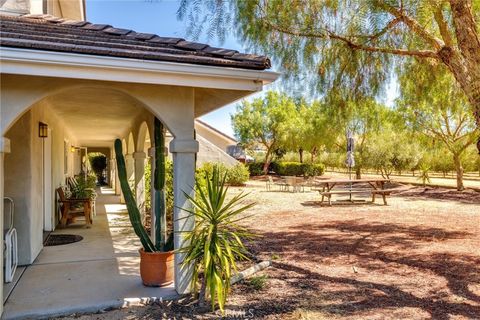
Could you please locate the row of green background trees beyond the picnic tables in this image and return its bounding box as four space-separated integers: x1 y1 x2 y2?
232 79 480 190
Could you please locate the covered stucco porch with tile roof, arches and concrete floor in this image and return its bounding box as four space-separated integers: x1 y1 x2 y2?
0 12 278 317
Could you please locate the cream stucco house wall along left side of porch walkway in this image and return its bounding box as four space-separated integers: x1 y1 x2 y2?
4 103 75 265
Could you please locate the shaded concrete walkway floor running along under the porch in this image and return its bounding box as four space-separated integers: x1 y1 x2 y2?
3 188 176 319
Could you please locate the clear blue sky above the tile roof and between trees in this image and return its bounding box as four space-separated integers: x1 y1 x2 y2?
86 0 397 136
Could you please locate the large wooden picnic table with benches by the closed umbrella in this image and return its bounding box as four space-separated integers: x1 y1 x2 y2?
314 178 392 205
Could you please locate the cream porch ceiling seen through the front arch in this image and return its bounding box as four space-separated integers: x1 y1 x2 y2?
47 88 144 146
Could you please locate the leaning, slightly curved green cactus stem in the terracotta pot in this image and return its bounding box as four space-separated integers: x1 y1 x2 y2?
115 139 158 252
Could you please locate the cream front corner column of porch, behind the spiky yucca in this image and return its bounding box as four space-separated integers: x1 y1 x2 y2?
170 139 198 294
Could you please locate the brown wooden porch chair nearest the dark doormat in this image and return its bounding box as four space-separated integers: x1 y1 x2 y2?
55 187 92 227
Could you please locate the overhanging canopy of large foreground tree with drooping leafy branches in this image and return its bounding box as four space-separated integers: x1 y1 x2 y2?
178 0 480 148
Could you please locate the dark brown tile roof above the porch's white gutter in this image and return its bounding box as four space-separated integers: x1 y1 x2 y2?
0 15 271 70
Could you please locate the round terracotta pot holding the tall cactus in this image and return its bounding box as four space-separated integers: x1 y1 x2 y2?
138 248 174 287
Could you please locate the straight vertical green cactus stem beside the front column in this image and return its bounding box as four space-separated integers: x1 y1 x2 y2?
153 118 170 251
